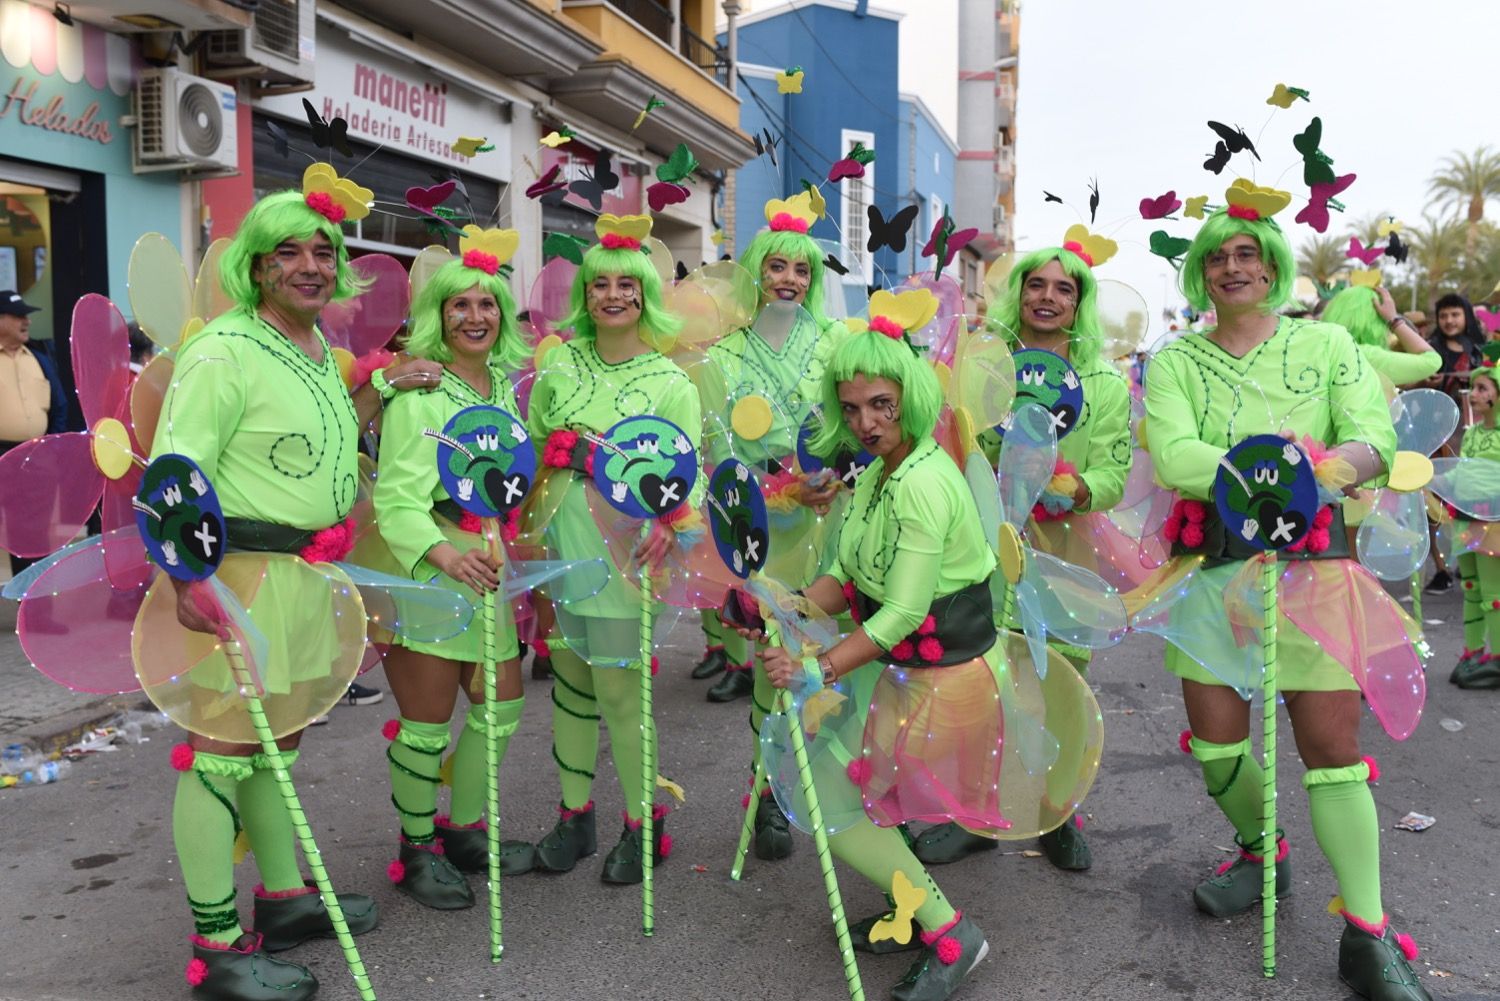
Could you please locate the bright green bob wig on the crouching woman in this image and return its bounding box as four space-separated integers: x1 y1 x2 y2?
810 330 942 458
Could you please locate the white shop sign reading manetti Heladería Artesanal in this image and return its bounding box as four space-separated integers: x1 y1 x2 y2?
254 23 510 180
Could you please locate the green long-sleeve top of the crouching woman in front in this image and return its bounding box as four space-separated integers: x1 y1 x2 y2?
830 438 995 650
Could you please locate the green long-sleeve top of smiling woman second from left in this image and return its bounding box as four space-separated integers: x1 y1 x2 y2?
375 365 521 581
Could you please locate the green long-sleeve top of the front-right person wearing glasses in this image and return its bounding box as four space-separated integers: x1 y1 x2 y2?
1146 318 1397 500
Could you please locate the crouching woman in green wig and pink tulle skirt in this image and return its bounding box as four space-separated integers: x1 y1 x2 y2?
761 317 1008 1001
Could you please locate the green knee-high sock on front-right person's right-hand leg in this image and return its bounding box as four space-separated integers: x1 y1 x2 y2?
1302 761 1385 924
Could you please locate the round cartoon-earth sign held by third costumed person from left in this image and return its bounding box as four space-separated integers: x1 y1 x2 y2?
594 417 698 518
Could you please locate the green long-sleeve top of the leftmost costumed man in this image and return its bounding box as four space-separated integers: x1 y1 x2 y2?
152 309 359 530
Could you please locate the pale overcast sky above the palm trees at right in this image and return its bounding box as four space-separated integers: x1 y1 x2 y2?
1014 0 1500 333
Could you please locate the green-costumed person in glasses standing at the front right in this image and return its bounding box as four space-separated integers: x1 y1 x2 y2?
1145 199 1428 1001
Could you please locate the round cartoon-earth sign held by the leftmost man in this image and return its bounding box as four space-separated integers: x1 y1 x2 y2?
131 453 227 581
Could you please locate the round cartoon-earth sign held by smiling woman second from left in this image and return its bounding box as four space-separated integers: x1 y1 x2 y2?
423 407 537 518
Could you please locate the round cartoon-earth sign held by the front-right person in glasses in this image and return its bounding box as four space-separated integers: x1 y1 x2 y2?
1214 434 1319 549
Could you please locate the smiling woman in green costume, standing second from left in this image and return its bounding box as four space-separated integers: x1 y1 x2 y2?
375 238 533 909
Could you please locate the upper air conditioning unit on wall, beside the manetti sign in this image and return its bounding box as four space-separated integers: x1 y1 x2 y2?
203 0 318 93
